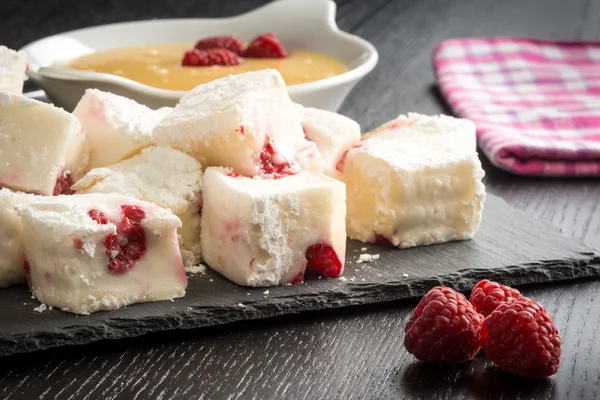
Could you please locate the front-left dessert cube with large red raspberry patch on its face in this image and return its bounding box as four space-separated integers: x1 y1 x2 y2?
17 194 187 314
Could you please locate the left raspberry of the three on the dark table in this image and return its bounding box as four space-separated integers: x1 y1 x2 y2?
404 286 483 364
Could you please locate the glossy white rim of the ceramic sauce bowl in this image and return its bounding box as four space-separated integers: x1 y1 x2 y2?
19 0 379 98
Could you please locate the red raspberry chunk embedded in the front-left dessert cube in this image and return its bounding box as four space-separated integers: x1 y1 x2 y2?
104 205 146 273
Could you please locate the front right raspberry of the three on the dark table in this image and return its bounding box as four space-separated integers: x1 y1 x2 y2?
481 297 561 379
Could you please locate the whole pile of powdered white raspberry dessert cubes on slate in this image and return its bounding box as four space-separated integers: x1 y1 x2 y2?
0 49 485 314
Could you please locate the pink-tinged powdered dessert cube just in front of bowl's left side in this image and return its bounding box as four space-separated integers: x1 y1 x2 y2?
73 89 164 170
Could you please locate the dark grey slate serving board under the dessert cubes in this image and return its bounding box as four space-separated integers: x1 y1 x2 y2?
0 196 600 356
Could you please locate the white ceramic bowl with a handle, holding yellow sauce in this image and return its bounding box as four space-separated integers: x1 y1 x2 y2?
22 0 378 111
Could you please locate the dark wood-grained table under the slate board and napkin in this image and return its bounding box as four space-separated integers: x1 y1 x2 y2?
0 0 600 400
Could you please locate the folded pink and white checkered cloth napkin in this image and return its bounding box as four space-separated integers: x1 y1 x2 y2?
433 38 600 176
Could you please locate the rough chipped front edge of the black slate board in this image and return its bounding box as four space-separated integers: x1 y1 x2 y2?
0 252 600 356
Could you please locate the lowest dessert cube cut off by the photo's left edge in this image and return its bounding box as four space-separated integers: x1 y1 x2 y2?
0 189 36 287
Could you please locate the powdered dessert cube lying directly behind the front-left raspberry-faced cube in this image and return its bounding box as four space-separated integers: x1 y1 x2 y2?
73 146 202 269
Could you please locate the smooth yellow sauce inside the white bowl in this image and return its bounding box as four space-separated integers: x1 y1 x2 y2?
61 43 348 90
